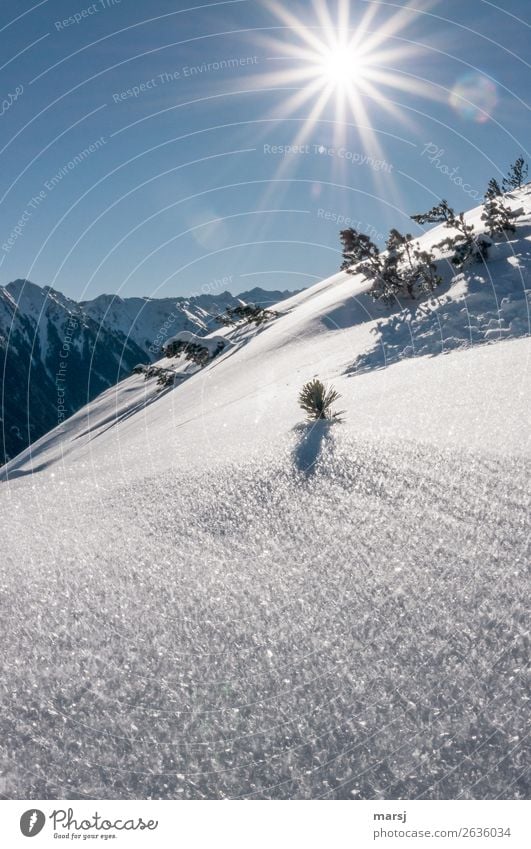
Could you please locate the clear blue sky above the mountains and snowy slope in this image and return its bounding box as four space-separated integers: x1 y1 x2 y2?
0 0 531 298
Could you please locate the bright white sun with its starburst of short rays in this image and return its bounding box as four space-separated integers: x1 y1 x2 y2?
255 0 432 152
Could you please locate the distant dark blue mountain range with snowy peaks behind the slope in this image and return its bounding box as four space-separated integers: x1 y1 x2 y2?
0 280 293 464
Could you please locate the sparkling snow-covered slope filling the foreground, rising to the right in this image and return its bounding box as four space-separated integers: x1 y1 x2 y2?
0 191 531 798
